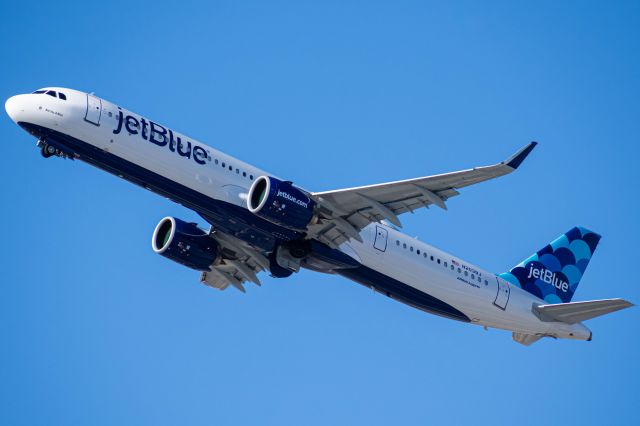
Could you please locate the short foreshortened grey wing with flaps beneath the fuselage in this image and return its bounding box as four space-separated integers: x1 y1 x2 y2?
200 231 269 293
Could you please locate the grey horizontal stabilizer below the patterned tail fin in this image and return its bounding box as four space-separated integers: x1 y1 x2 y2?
533 299 633 324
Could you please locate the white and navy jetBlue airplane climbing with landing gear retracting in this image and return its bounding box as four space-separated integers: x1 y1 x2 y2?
5 87 633 346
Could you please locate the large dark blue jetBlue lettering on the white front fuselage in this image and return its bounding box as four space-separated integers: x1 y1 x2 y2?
113 109 207 164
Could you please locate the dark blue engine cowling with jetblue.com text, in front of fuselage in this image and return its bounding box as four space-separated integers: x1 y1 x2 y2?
247 176 315 232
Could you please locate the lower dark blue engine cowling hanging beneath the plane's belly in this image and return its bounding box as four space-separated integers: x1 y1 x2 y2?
151 217 220 271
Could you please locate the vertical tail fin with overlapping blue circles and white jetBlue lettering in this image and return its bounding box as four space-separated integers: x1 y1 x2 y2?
500 226 600 303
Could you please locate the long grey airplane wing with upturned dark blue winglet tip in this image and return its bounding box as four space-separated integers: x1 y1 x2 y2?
309 142 537 247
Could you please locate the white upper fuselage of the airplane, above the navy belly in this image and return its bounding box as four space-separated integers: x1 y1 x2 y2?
6 88 591 340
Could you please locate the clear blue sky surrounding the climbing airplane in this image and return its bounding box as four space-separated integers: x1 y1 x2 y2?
0 1 640 425
